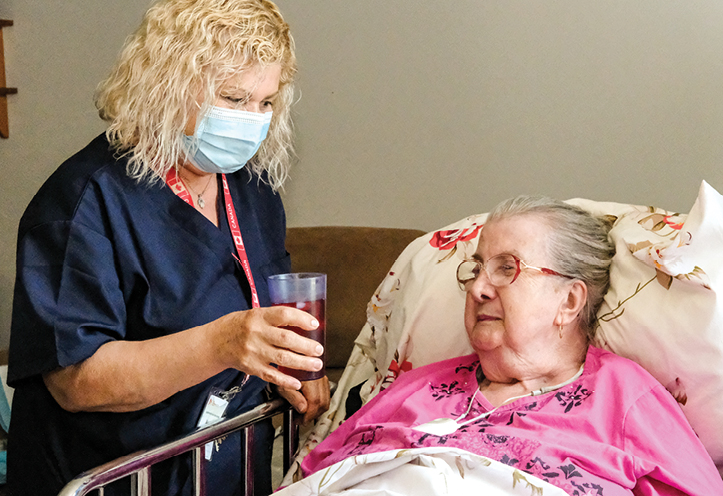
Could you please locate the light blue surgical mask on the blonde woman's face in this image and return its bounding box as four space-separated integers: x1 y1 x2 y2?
185 107 273 174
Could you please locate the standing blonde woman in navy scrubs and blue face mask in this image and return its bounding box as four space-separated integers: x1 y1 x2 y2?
8 0 329 496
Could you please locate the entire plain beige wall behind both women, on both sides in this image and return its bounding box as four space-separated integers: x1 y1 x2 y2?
0 0 723 346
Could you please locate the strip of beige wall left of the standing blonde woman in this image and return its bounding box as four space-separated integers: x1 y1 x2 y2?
0 0 150 348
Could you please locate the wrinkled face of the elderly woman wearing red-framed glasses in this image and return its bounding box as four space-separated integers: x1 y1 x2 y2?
465 215 568 378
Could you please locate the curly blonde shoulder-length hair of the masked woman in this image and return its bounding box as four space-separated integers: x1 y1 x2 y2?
95 0 296 190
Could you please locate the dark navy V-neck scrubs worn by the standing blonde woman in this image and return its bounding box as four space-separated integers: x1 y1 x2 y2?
8 136 290 496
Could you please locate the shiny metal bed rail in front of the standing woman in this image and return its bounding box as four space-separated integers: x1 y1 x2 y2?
58 398 299 496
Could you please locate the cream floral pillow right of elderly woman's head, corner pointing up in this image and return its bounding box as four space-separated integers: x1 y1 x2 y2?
588 182 723 468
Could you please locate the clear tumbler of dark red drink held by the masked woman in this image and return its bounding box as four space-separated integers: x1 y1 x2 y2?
269 272 326 381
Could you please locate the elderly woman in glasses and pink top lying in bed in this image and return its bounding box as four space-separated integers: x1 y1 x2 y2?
296 197 723 496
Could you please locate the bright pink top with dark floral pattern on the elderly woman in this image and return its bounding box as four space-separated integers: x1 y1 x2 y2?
302 347 723 496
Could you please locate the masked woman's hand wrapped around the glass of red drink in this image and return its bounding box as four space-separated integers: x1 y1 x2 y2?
208 306 328 392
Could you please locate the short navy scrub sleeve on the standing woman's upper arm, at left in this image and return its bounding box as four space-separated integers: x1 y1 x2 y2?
8 221 126 383
